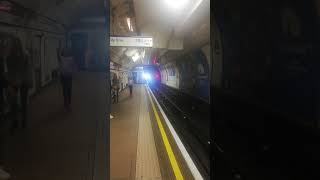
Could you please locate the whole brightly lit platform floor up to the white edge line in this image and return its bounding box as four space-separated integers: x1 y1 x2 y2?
110 84 198 180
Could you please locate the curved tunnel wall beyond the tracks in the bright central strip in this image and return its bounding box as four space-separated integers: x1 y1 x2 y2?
160 45 211 102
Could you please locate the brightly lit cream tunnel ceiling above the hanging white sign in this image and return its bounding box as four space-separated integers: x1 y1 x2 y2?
110 0 210 68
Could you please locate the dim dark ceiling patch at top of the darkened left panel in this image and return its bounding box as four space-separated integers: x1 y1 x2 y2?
10 0 104 29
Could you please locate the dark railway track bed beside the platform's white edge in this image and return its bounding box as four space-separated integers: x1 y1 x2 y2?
150 85 210 179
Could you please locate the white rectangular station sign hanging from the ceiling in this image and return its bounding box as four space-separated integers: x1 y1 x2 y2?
110 36 153 47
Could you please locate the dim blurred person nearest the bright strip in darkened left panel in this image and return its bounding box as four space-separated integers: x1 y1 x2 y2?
58 48 76 111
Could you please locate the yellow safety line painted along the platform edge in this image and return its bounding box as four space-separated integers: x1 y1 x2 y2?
147 86 183 180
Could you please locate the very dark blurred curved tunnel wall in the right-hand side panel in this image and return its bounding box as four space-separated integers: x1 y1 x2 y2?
214 0 319 127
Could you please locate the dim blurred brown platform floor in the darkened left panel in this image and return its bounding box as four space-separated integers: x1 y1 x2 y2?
1 72 107 180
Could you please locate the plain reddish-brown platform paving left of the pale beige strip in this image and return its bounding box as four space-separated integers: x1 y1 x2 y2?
110 86 141 180
